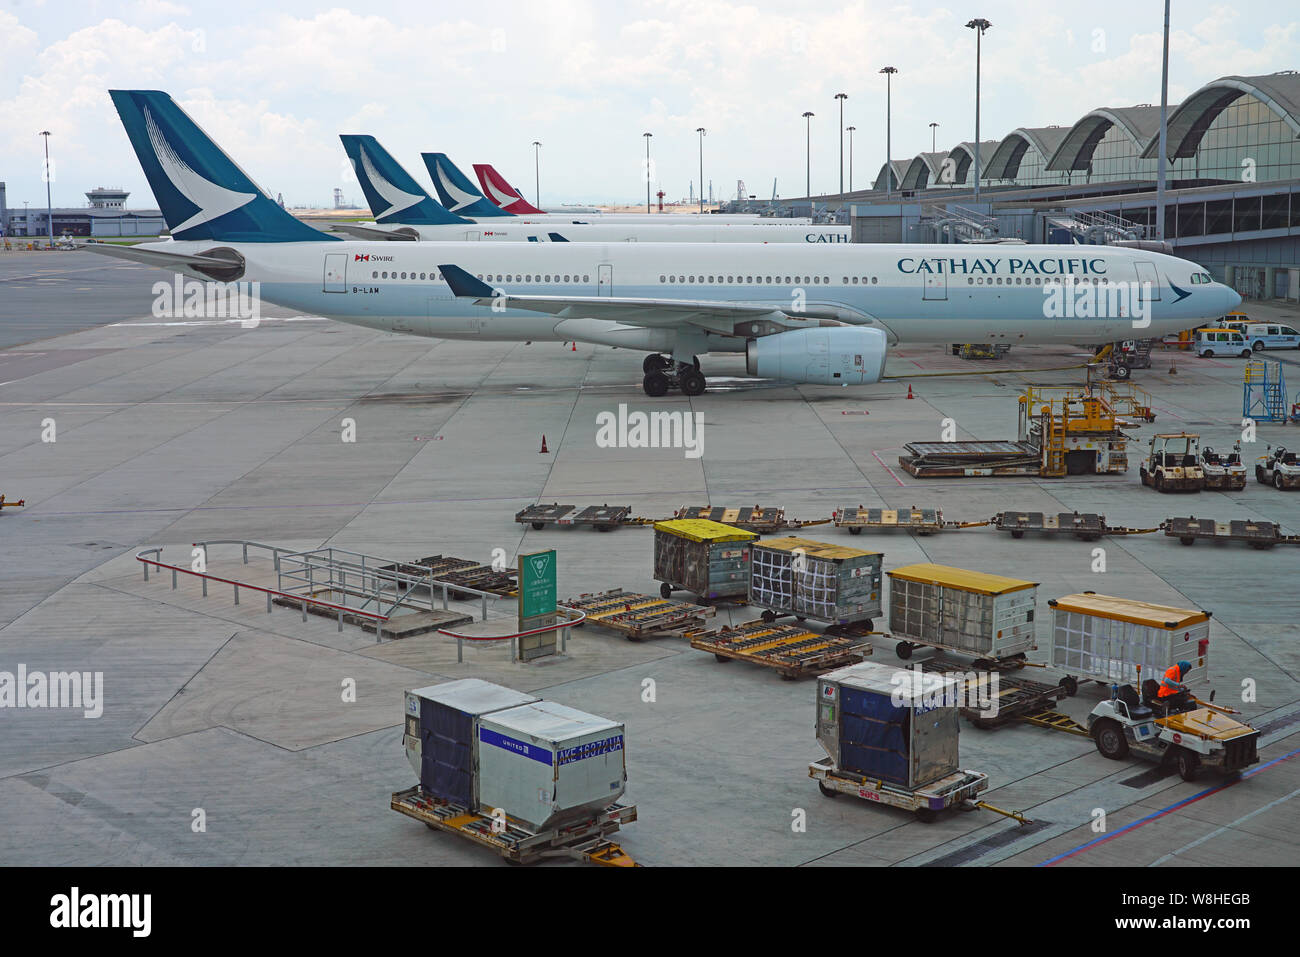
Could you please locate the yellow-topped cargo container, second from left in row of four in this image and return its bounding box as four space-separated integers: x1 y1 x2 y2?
749 536 884 631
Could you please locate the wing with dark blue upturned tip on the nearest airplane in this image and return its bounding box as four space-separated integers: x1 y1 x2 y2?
438 264 800 335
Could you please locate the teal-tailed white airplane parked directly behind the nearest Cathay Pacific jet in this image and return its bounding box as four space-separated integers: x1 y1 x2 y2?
334 133 853 243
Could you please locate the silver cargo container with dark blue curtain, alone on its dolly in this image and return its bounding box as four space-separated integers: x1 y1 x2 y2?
816 662 959 791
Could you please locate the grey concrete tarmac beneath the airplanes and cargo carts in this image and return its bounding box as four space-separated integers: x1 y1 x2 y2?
0 252 1300 866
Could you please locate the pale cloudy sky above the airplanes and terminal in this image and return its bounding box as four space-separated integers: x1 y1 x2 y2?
0 0 1300 208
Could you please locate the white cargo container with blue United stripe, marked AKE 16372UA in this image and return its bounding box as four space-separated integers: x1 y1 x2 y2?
477 701 628 830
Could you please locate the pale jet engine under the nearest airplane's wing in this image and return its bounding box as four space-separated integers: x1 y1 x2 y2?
745 326 888 385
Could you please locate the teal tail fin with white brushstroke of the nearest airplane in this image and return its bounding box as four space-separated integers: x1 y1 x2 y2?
108 90 337 243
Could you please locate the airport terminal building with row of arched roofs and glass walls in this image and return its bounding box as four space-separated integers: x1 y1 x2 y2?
732 70 1300 300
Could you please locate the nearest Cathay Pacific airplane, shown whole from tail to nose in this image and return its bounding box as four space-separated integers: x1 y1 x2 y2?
81 90 1242 397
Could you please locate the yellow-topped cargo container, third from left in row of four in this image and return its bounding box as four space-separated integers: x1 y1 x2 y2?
888 564 1039 661
